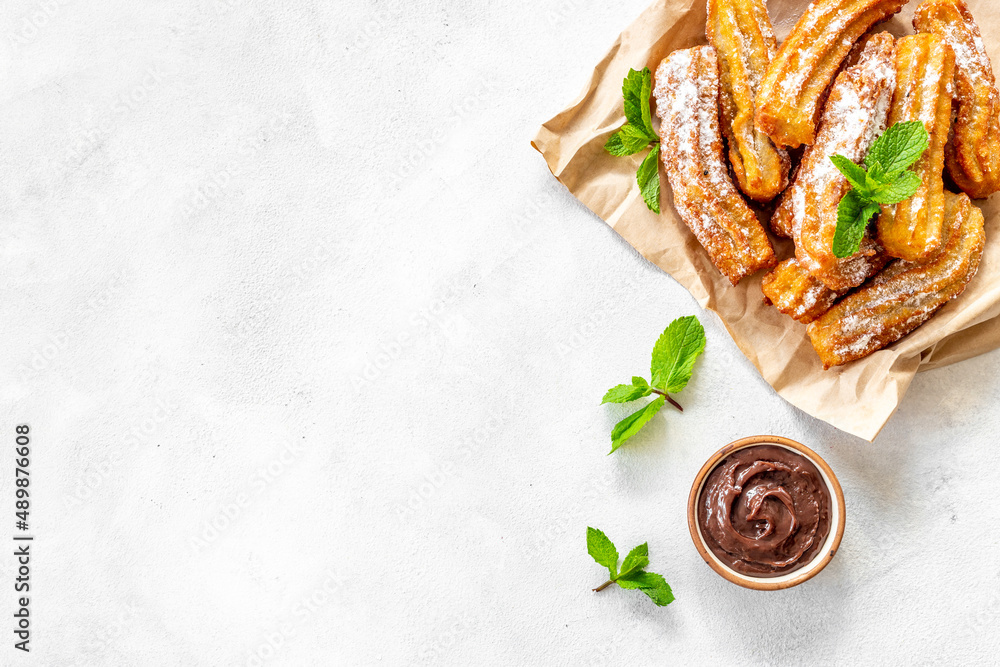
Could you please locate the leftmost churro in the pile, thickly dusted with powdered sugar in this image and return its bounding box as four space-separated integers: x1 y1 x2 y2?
653 46 776 285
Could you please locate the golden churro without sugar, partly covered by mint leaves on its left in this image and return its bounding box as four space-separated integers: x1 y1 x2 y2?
878 34 955 262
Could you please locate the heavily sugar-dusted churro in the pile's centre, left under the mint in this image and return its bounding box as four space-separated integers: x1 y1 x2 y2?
771 33 896 291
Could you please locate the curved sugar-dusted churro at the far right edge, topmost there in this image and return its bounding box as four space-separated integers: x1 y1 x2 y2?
913 0 1000 199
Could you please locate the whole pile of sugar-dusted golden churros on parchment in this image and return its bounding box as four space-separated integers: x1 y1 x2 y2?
652 0 1000 368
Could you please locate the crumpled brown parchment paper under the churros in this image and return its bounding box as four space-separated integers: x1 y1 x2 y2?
532 0 1000 440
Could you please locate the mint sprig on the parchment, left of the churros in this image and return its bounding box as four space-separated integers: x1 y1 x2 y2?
604 67 660 213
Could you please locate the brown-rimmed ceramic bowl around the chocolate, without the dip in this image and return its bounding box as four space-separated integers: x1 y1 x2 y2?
688 435 846 591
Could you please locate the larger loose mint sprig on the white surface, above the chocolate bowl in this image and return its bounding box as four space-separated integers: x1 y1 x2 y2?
601 315 705 454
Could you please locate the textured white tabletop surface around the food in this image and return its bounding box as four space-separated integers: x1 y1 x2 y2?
0 0 1000 666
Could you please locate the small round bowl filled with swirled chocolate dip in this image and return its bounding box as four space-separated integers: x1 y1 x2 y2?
688 435 845 590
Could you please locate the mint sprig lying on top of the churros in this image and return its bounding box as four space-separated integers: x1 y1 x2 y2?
830 120 930 257
